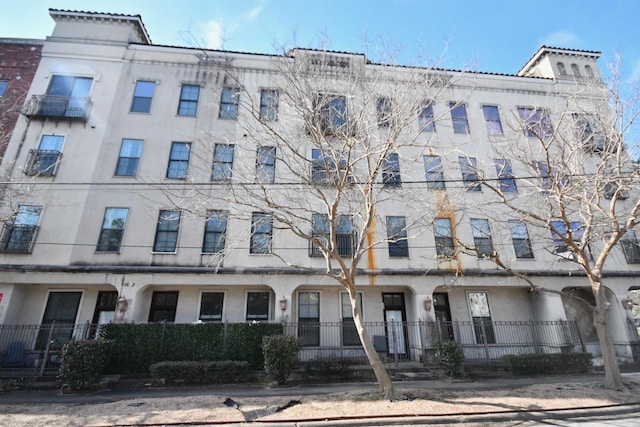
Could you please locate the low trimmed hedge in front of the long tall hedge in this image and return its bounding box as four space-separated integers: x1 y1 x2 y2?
149 360 251 384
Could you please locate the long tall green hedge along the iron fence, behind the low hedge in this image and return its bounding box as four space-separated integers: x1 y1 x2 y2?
100 323 282 375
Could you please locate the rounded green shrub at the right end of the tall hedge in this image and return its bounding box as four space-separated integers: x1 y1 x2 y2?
262 335 299 384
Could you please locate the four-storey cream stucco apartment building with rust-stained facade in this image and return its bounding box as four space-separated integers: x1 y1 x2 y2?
0 10 640 360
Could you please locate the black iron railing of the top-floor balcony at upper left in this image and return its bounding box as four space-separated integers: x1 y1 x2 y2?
22 95 92 122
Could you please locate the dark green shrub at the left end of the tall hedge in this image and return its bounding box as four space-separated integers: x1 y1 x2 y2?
58 339 113 390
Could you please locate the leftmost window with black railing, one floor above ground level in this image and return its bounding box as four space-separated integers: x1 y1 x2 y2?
1 205 42 254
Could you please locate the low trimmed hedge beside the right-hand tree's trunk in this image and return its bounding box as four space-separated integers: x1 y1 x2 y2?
500 353 593 376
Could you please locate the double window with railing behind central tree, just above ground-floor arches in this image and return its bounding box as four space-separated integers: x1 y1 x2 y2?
310 214 355 257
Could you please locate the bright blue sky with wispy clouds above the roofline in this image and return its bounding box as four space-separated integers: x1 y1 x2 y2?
0 0 640 81
